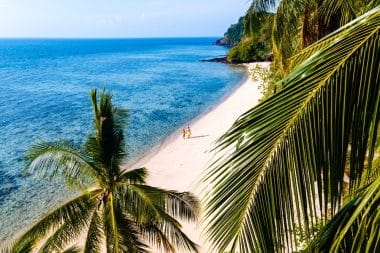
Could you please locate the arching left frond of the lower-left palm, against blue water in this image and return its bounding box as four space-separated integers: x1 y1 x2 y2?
26 141 102 185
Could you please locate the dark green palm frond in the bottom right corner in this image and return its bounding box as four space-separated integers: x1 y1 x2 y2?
308 177 380 253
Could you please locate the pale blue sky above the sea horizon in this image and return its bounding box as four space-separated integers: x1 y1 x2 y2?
0 0 250 38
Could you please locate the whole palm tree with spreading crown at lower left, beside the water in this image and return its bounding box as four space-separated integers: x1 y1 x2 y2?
7 90 198 252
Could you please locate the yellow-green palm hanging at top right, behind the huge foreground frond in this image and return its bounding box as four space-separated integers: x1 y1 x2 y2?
247 0 380 77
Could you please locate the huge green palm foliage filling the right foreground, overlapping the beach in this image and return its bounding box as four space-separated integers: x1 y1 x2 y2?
204 7 380 253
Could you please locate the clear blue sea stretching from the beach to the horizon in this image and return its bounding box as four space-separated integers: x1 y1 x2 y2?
0 38 244 241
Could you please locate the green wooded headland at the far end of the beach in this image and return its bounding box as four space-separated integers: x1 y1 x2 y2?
216 13 274 63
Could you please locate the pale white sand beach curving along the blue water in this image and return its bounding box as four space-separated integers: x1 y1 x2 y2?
132 63 269 252
